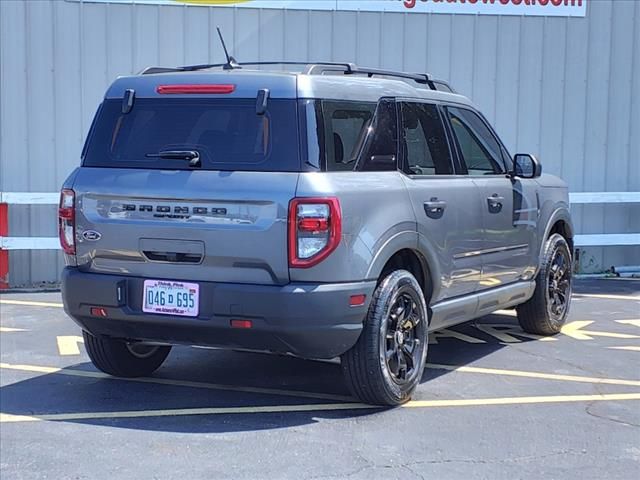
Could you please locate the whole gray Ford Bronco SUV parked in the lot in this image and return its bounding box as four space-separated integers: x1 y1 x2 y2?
59 62 573 405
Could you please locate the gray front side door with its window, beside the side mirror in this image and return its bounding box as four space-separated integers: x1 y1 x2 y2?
446 106 538 289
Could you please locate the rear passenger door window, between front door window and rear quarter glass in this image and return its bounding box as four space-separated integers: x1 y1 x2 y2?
400 102 453 175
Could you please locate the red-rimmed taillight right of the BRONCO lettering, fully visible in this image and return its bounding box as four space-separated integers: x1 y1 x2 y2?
289 197 342 268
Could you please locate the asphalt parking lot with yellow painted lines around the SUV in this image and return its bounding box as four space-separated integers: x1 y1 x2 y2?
0 280 640 480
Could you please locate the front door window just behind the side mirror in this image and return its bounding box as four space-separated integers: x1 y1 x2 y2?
447 107 505 175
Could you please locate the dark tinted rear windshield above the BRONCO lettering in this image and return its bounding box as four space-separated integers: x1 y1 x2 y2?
83 98 300 171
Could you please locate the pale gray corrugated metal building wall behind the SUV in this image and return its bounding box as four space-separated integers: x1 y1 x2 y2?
0 0 640 285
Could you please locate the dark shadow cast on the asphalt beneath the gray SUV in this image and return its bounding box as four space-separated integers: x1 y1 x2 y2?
0 315 526 433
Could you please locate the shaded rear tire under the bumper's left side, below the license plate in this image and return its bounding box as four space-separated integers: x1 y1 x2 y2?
82 331 171 378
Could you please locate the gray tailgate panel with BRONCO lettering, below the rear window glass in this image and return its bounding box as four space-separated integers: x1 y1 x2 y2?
73 167 298 285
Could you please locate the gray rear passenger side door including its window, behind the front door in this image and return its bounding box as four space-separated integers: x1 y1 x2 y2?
399 101 482 302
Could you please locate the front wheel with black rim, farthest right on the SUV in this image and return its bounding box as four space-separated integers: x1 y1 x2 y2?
516 233 572 335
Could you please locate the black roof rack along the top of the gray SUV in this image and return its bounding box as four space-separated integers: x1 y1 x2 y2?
139 61 455 93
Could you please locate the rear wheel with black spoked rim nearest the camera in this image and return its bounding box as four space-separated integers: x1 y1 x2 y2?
342 270 428 406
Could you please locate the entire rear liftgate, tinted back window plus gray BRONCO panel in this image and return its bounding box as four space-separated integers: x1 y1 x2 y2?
73 97 300 284
